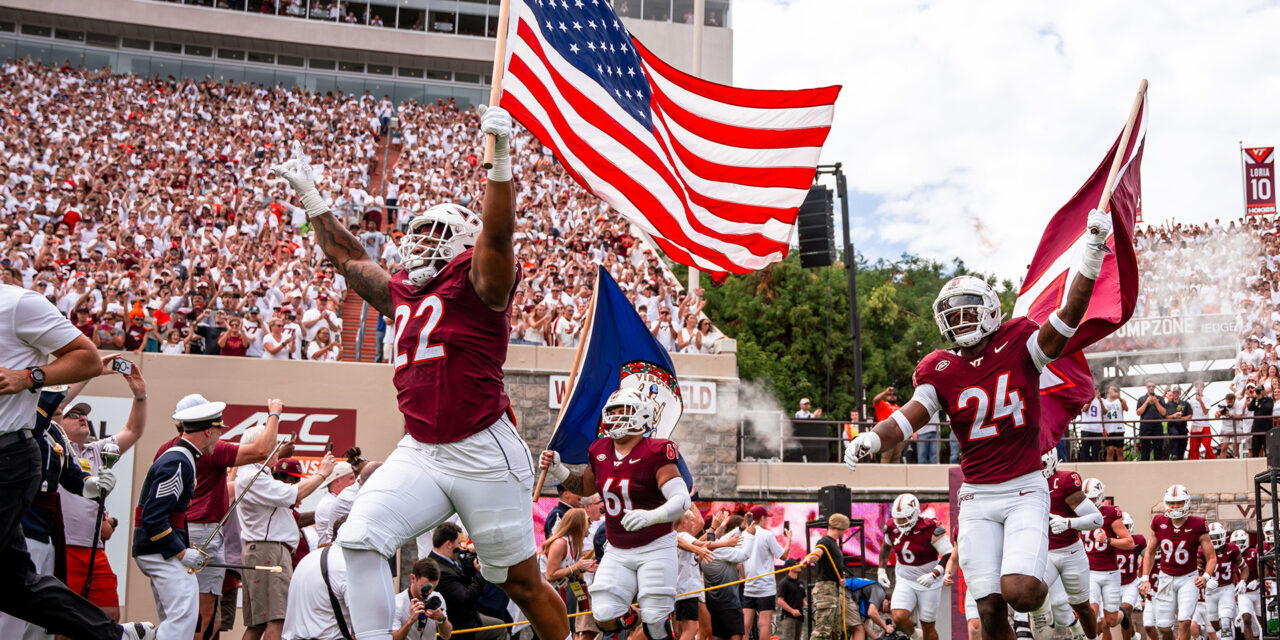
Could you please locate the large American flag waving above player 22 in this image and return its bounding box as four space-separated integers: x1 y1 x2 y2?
499 0 840 279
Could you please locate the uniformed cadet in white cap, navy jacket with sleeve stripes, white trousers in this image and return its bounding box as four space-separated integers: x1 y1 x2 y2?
133 402 227 640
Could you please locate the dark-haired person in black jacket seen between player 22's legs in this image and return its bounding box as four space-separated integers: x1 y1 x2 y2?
430 522 506 640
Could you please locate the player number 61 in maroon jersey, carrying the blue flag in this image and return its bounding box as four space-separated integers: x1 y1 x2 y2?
540 387 691 640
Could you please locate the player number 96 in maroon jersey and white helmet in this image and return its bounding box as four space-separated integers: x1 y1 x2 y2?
1138 484 1217 640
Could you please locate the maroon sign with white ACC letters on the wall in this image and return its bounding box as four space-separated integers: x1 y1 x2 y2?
223 404 356 457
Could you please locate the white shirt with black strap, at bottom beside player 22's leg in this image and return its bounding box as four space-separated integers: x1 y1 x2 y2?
280 547 351 640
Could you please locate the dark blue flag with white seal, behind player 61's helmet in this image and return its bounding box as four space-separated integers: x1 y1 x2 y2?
549 268 690 465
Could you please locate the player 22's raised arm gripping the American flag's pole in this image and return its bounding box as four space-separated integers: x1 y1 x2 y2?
468 105 516 315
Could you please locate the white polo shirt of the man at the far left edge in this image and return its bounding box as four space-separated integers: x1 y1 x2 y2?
0 284 83 434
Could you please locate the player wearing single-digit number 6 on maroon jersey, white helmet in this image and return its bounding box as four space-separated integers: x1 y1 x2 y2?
878 493 951 640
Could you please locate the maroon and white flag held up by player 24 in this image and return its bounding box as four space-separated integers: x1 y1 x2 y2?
1014 93 1147 451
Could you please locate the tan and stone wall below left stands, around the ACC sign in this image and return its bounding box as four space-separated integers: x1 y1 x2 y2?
74 346 739 620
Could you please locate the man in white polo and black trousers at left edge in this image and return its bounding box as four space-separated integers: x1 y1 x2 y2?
0 284 155 640
